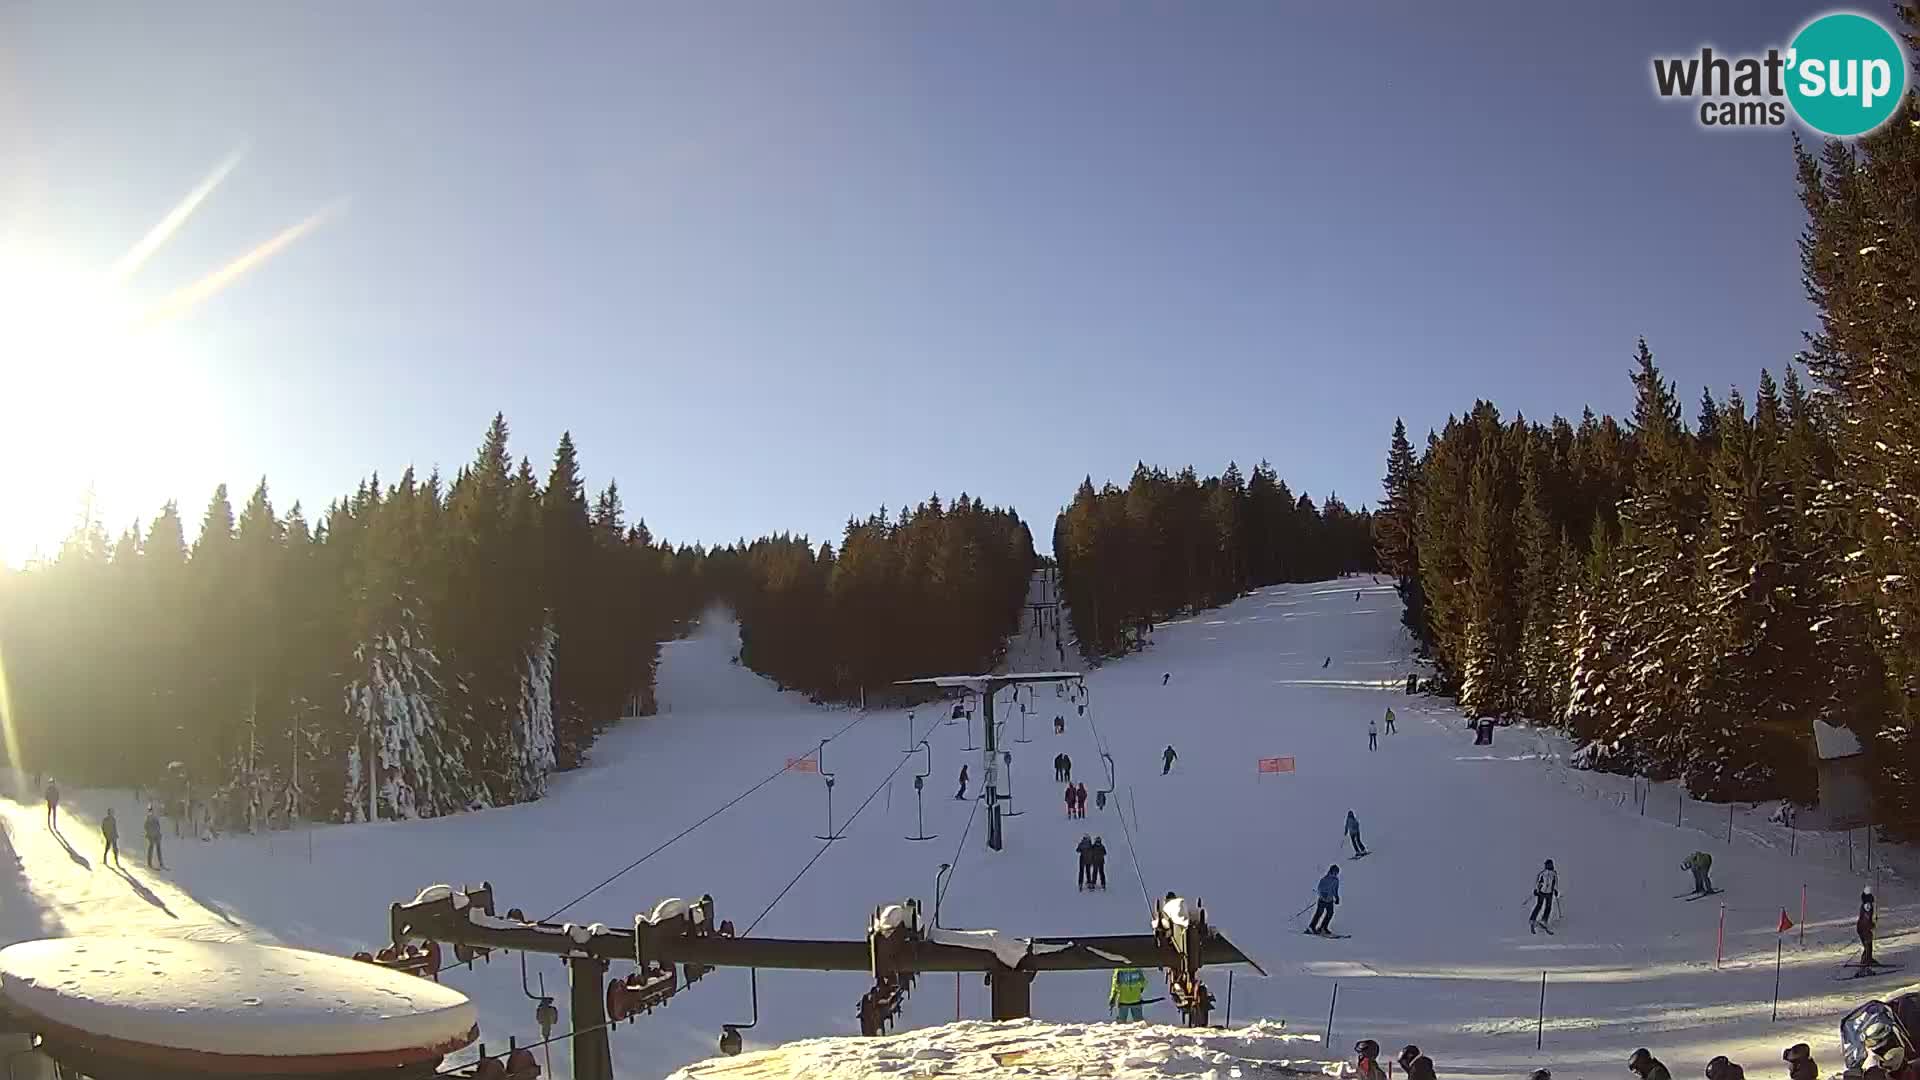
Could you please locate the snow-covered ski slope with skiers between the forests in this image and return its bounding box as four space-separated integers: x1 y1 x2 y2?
0 577 1916 1078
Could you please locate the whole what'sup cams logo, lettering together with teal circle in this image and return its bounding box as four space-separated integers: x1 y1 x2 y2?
1653 12 1907 138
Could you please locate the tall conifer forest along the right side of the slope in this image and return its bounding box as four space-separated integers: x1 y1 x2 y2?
1375 35 1920 822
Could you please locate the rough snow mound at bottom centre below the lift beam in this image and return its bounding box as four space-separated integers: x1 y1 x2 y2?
668 1020 1327 1080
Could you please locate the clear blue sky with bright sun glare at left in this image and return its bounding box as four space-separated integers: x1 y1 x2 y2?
0 0 1858 563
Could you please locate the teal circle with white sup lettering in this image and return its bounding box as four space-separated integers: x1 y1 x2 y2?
1788 12 1907 138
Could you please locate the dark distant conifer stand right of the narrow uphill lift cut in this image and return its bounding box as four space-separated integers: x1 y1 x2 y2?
1054 461 1377 659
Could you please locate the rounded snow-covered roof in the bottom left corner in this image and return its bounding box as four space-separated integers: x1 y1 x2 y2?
0 938 480 1061
